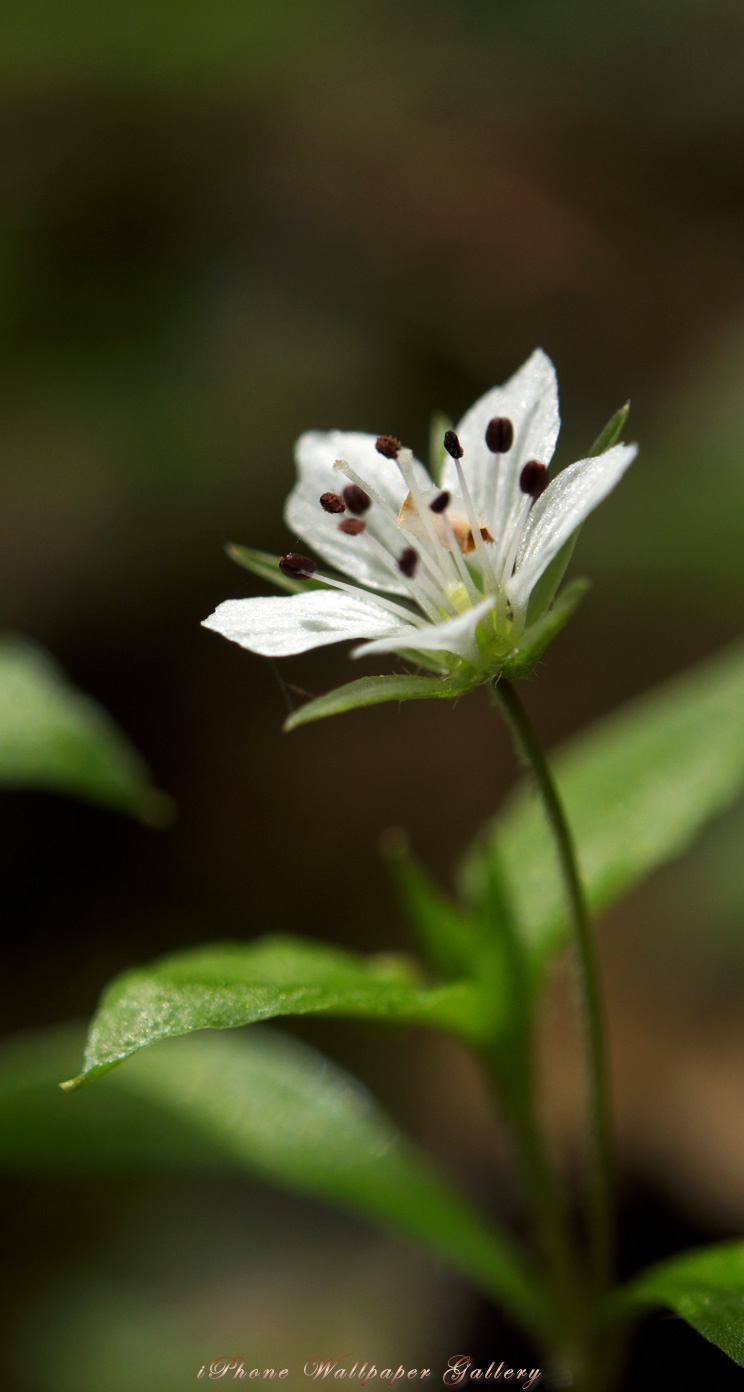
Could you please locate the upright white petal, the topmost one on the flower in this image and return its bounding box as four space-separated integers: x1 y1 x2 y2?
442 348 560 558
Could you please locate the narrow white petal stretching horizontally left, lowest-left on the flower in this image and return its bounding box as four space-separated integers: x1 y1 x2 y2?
203 590 409 657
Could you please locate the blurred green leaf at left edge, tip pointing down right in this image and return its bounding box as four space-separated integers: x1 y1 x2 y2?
0 638 173 825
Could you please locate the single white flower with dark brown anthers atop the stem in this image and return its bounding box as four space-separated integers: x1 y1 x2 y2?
205 349 637 683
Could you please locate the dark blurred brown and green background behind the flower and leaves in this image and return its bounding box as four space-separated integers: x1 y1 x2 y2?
0 0 744 1392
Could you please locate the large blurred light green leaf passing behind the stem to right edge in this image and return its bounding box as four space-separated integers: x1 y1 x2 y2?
463 644 744 981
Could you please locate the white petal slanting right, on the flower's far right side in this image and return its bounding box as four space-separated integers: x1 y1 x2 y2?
506 444 638 607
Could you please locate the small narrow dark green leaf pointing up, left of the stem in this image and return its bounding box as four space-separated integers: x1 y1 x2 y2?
382 828 482 980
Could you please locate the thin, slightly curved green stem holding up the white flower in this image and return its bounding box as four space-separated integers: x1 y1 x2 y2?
493 679 614 1295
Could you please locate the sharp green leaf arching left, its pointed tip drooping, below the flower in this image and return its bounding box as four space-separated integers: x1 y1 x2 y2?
61 937 482 1090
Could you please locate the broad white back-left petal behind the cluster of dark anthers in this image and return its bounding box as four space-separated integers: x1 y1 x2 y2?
284 430 432 594
